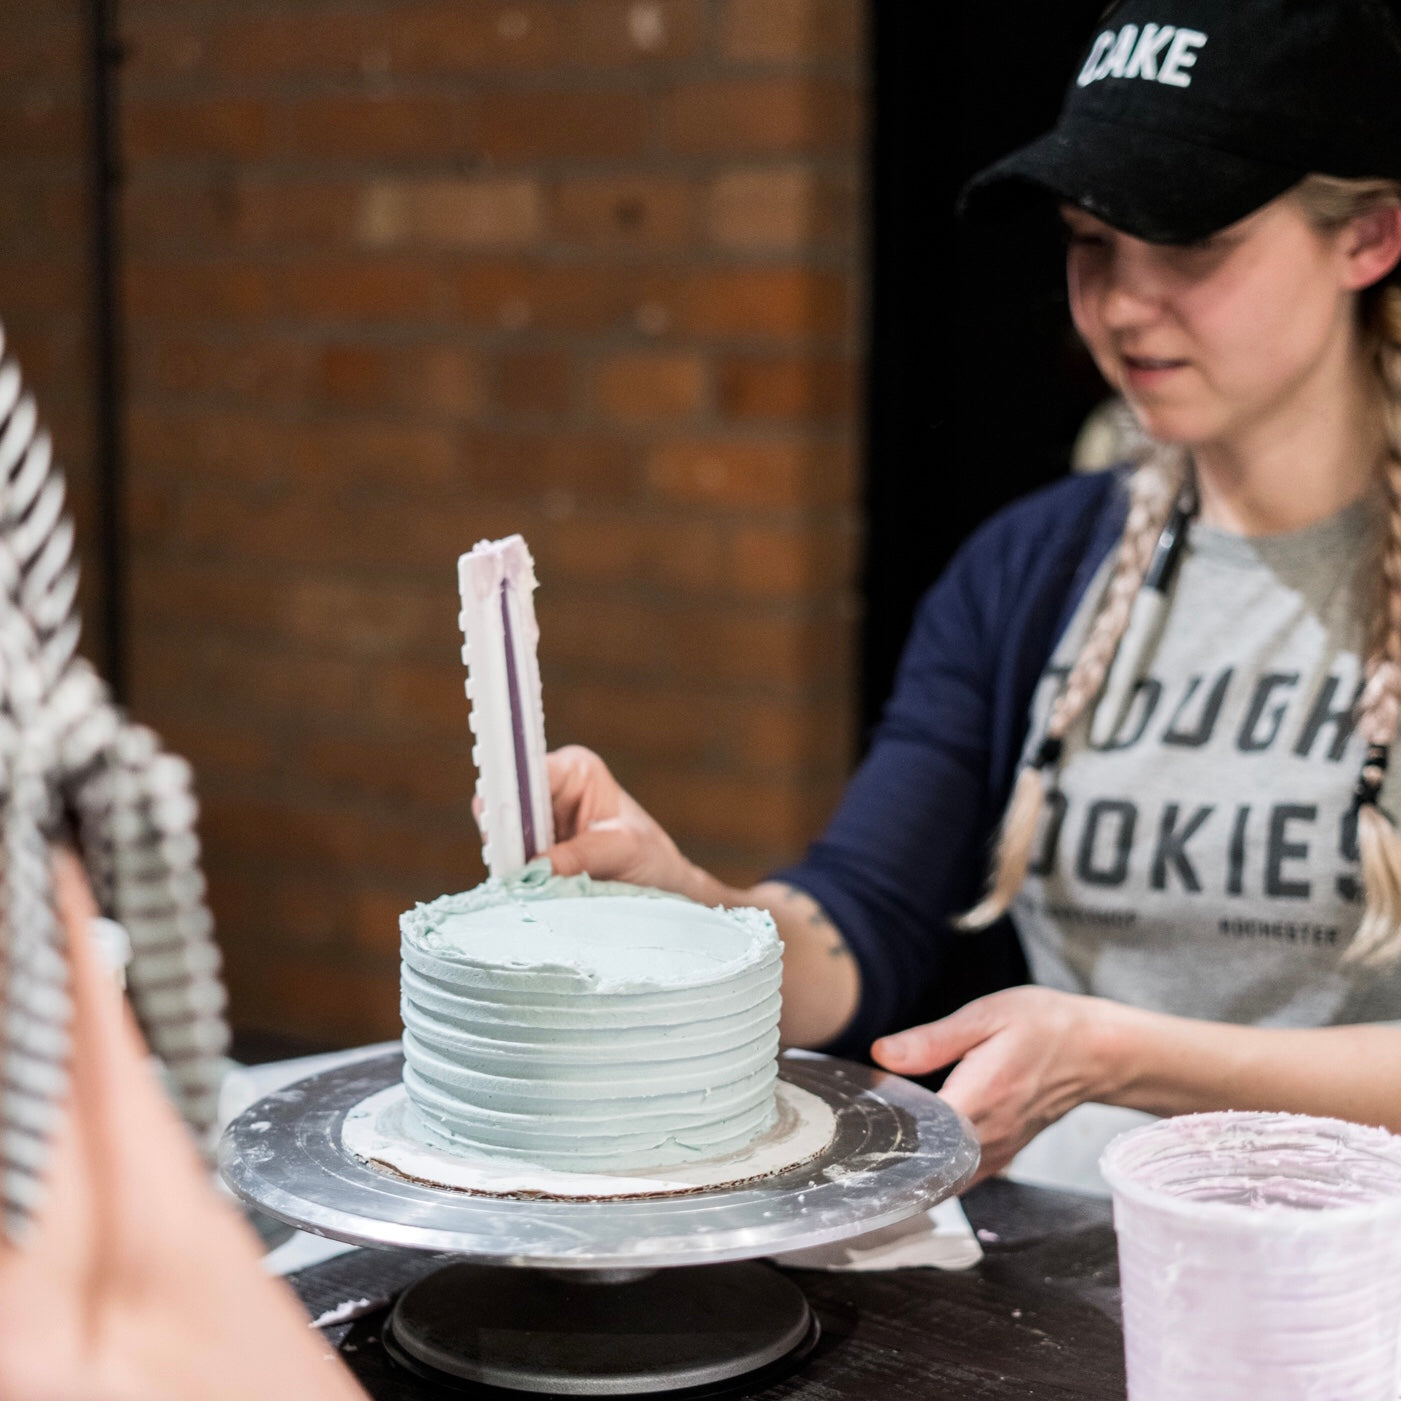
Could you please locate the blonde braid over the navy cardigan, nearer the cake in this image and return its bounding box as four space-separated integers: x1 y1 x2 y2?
955 446 1187 929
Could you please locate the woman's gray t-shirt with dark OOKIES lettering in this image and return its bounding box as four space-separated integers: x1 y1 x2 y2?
1013 500 1401 1027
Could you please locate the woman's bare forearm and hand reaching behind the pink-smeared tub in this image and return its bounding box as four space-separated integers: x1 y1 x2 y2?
871 988 1401 1177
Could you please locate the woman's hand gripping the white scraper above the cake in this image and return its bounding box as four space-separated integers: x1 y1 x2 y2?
545 744 713 899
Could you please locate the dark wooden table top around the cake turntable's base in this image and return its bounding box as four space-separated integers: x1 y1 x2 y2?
290 1181 1124 1401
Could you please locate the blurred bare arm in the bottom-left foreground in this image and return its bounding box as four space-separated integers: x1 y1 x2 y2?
0 852 366 1401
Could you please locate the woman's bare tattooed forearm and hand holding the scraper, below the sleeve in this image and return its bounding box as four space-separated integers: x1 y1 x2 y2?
546 745 860 1047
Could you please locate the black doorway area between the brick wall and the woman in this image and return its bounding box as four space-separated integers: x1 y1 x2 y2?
862 0 1105 733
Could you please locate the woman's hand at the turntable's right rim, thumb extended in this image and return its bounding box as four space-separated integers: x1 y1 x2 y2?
871 988 1104 1181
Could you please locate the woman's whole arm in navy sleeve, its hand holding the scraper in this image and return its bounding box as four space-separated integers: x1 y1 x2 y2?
548 478 1119 1056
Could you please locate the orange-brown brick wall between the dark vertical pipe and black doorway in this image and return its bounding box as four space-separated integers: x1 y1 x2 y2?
117 0 863 1041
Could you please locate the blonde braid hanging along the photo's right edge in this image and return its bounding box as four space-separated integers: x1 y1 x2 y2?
1344 284 1401 964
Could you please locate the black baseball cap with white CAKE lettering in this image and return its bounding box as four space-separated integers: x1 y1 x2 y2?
960 0 1401 244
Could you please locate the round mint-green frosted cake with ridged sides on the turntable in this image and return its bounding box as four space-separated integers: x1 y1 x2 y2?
401 863 782 1173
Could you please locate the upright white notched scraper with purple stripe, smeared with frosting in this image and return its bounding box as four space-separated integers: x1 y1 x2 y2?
457 535 555 877
